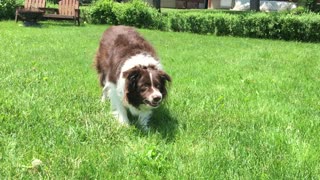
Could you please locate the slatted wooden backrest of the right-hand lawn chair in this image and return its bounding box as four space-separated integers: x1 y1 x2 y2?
59 0 79 16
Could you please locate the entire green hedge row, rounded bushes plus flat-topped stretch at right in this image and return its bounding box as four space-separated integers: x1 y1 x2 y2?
82 0 320 42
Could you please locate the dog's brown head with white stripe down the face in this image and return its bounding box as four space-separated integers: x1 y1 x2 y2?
123 66 171 108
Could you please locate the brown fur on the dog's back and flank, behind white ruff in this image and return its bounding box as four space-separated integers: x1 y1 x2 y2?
94 26 157 86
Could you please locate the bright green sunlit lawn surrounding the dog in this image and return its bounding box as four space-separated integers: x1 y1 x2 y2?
0 21 320 179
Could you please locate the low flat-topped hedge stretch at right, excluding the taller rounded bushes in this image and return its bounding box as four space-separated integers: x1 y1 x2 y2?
169 12 320 41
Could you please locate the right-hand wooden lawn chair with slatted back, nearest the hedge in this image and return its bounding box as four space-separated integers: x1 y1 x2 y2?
40 0 80 26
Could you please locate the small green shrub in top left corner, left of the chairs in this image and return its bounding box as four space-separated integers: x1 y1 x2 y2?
0 0 17 19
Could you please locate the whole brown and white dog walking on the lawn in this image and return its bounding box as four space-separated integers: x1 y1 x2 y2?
95 26 171 129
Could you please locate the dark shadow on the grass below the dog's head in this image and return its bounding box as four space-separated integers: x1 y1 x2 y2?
131 106 178 142
